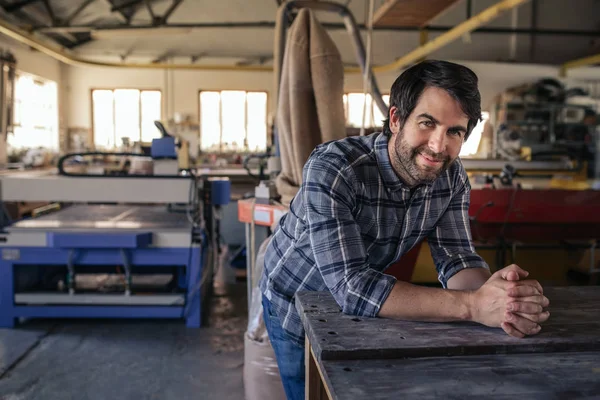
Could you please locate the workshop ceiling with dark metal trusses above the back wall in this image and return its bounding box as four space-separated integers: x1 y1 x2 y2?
0 0 600 65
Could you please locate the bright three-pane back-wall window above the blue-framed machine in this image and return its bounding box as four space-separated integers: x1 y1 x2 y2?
92 89 162 148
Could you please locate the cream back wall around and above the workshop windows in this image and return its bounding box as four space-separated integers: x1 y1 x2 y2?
66 61 600 128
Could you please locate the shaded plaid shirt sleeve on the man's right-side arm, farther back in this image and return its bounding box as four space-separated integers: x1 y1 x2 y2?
427 170 489 288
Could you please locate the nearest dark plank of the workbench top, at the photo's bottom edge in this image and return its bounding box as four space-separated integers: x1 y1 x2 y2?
322 352 600 400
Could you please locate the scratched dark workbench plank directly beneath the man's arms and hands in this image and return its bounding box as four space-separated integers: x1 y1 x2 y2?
296 287 600 360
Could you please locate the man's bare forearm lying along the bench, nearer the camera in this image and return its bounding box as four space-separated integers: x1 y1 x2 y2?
378 281 471 322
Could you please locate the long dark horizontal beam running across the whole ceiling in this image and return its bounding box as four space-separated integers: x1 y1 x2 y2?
33 21 600 38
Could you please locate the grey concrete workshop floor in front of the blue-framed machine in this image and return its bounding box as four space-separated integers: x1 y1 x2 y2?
0 283 247 400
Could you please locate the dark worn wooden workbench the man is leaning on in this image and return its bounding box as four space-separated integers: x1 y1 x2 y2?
296 287 600 400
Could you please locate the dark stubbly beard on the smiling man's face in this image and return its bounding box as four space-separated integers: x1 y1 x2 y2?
391 130 454 187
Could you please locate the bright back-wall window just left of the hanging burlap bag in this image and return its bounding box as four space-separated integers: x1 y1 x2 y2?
200 90 267 152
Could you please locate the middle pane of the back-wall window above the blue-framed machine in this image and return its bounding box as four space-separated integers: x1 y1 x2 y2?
115 89 140 146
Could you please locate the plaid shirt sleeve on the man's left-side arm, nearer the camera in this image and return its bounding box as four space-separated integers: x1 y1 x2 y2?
301 157 396 317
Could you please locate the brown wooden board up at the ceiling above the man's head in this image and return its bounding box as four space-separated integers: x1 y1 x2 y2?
373 0 458 27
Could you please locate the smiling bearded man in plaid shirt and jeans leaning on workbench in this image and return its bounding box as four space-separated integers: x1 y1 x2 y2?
260 61 549 399
